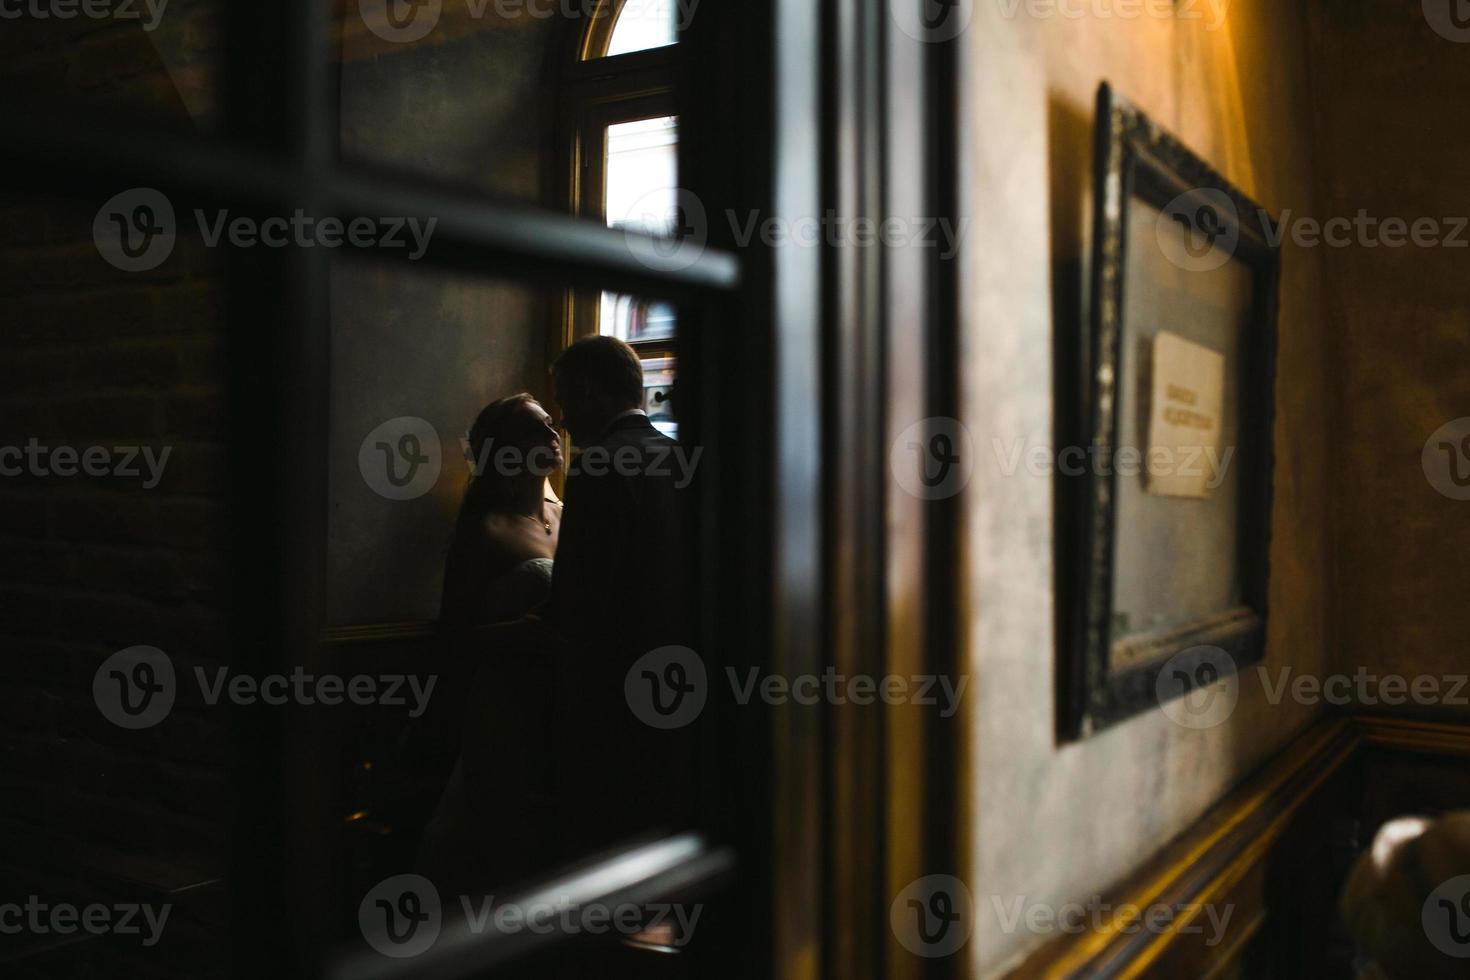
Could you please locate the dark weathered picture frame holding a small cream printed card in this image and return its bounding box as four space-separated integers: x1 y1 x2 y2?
1058 84 1280 738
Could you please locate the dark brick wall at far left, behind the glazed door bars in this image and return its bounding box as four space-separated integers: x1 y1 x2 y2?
0 0 234 977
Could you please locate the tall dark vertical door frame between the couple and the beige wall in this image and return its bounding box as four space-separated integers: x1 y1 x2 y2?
684 0 964 980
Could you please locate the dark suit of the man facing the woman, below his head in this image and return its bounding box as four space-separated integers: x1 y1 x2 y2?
545 414 692 858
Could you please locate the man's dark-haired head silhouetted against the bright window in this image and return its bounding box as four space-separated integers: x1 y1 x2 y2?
551 336 642 445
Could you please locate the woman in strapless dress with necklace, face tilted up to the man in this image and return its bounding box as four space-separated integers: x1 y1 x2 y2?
419 392 563 895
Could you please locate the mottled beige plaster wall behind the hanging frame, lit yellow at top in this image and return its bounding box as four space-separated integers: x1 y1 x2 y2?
960 0 1332 976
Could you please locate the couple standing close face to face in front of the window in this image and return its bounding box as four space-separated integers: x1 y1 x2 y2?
420 336 692 893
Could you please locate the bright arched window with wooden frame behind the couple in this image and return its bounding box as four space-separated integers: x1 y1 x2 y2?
562 0 691 435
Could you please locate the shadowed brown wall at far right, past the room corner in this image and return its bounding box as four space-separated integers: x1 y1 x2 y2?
1310 0 1470 720
